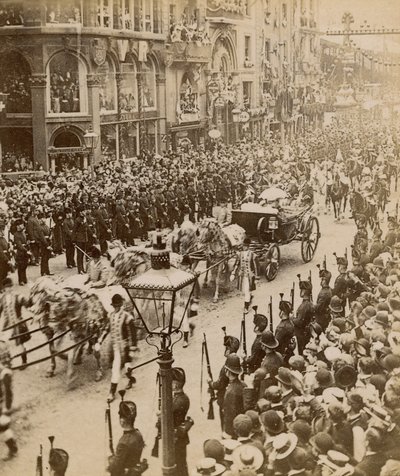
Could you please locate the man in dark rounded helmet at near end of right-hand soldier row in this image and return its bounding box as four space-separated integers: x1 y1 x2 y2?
223 354 245 438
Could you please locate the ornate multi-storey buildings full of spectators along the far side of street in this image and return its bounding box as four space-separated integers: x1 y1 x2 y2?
0 0 318 170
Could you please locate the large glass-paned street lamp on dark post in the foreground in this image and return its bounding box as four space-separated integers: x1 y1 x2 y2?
124 231 197 476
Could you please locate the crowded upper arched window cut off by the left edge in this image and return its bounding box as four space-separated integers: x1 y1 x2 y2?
0 51 32 114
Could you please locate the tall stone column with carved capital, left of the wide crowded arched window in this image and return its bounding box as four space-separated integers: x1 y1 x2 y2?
31 74 50 170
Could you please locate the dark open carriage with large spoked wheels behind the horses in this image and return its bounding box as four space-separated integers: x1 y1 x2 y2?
232 204 320 281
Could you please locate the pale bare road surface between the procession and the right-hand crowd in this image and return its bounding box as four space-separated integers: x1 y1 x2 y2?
0 209 382 476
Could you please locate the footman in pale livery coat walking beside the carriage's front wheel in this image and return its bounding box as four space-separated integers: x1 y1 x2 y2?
231 238 257 314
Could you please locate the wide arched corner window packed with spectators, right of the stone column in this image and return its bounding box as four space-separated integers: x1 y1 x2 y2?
47 52 87 115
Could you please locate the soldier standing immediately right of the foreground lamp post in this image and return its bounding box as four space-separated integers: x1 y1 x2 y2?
172 367 193 476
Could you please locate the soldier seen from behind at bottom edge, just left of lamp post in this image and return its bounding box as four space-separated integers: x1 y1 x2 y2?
107 401 148 476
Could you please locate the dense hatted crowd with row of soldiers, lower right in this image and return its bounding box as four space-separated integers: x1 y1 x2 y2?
198 218 400 476
